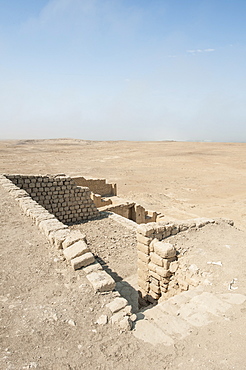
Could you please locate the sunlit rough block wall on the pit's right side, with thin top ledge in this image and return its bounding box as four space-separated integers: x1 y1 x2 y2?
137 218 215 306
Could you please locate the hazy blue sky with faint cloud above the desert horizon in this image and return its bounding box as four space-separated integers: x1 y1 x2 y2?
0 0 246 142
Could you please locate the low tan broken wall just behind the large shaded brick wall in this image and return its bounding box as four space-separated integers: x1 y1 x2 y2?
72 176 117 196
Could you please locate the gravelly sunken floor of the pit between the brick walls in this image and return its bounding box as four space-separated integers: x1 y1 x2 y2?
70 213 138 312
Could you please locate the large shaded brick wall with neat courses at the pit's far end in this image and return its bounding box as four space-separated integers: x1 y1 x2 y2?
5 175 99 223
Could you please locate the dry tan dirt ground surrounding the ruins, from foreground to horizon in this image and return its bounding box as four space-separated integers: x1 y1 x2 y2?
0 139 246 370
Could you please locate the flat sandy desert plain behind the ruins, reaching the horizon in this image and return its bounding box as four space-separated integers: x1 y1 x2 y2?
0 139 246 227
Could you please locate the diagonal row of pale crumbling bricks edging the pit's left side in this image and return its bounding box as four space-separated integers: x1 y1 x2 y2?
0 174 134 331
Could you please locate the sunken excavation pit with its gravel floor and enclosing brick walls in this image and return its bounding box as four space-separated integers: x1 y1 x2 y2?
2 175 211 312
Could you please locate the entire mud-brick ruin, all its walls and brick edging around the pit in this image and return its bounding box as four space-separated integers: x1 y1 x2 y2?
0 174 232 329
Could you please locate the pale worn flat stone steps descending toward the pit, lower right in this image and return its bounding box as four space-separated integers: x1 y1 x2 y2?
133 287 246 345
